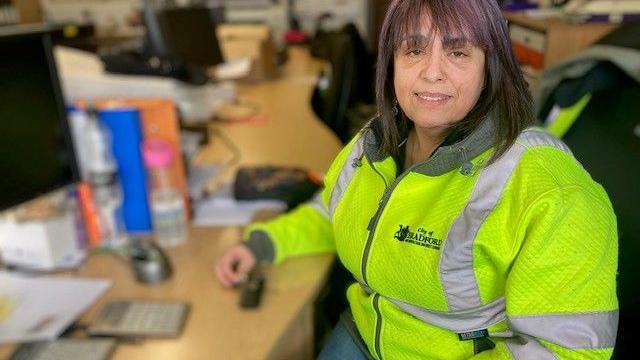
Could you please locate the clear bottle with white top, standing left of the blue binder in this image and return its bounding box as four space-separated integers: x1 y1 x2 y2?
84 111 127 248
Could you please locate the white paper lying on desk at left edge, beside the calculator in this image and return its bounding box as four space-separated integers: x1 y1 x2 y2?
0 271 111 343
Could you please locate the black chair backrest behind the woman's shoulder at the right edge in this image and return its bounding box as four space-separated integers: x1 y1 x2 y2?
564 71 640 358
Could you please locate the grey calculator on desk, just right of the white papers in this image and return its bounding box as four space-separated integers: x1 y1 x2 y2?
87 300 189 338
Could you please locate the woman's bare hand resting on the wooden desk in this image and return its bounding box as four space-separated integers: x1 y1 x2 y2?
216 243 256 288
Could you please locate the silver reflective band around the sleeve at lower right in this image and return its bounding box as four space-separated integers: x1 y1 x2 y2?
507 311 618 349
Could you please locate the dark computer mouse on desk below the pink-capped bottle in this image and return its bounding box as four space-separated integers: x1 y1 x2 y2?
131 241 172 284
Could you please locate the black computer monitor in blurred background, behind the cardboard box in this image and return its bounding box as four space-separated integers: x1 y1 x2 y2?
157 6 224 66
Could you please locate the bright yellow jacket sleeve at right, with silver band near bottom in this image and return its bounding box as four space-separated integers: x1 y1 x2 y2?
475 186 618 359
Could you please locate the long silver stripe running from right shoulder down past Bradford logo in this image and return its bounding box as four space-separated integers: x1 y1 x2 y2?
439 129 570 311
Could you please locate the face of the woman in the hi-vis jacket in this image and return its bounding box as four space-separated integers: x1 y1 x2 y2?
394 22 485 131
